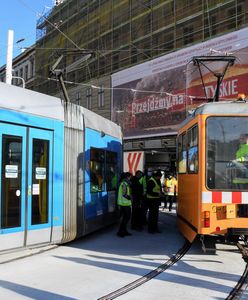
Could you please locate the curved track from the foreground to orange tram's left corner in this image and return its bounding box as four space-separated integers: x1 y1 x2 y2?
97 241 192 300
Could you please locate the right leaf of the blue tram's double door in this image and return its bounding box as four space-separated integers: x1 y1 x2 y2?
26 128 53 245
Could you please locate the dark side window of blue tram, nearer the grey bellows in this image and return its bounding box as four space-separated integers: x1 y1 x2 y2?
90 148 105 193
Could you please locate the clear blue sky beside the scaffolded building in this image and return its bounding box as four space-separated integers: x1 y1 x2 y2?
0 0 54 66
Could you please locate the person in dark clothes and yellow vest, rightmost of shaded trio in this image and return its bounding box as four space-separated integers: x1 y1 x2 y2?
147 170 162 233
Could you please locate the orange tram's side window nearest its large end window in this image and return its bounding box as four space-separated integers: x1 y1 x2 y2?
187 126 198 173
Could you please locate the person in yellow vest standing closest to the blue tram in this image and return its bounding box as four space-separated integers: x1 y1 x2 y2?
117 172 132 237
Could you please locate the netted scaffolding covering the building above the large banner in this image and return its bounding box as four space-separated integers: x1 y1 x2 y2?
36 0 248 106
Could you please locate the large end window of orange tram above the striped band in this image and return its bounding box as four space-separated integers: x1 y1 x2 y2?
206 117 248 190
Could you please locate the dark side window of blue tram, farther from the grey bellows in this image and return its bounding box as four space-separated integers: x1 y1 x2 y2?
106 151 118 191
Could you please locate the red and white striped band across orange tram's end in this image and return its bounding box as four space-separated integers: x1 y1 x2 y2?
202 192 248 204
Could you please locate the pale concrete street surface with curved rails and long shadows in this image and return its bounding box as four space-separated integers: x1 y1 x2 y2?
0 209 248 300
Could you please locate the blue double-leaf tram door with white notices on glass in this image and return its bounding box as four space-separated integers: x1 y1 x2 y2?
0 123 52 250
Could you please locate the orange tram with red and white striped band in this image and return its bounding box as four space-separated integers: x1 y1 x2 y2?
177 101 248 242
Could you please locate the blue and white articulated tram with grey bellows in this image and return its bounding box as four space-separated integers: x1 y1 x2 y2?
0 83 122 251
